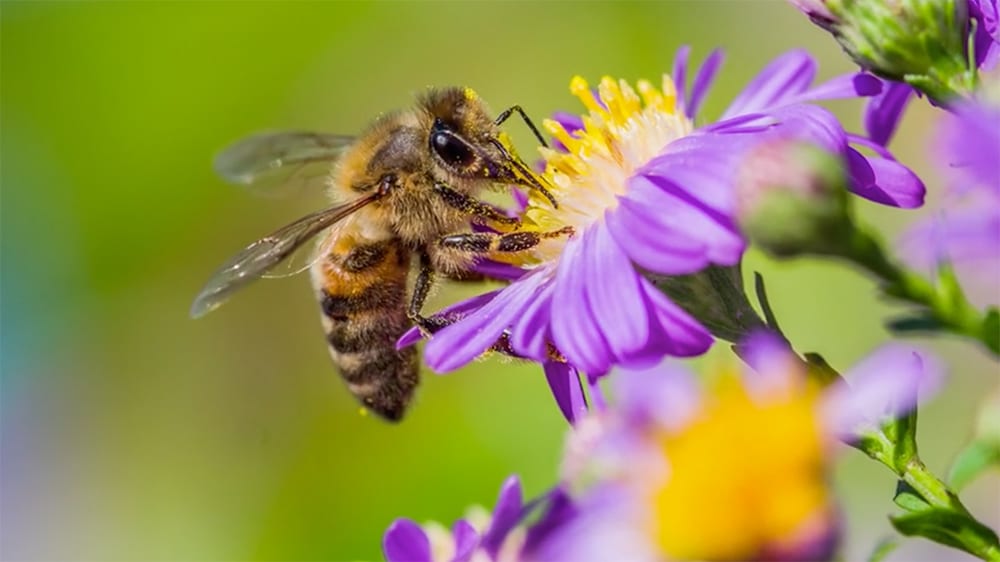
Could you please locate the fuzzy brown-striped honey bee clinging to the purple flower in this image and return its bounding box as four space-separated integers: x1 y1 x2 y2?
191 88 568 421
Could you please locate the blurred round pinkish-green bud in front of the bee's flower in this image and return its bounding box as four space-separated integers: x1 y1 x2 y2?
737 140 853 257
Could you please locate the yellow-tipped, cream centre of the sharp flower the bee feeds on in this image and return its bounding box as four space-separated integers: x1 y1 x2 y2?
522 76 693 263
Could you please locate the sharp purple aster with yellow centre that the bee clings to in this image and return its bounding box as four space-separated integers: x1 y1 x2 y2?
406 49 923 378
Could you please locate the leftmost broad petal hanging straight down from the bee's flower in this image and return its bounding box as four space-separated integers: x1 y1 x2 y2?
552 234 612 375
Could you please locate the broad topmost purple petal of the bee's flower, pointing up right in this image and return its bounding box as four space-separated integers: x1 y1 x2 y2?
722 49 816 119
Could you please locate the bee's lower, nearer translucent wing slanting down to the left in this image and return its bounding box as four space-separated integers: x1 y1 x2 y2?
191 192 379 318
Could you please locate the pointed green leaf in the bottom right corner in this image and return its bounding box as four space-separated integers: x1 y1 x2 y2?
889 507 1000 560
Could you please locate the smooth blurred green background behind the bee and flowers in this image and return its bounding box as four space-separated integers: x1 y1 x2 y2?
0 0 1000 560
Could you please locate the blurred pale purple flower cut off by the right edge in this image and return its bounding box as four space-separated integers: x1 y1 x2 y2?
900 97 1000 305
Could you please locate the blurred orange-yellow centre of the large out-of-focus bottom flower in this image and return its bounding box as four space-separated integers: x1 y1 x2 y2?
651 378 829 560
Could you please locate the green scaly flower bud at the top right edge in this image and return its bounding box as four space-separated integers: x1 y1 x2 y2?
791 0 975 102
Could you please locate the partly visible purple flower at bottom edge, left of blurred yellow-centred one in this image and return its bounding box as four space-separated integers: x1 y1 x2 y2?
382 476 524 562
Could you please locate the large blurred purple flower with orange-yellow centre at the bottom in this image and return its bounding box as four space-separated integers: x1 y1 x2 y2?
523 335 941 562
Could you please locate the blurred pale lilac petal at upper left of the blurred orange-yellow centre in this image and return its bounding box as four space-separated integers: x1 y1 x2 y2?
612 363 701 430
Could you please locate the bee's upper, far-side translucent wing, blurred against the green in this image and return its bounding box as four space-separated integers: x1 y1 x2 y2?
213 131 354 197
